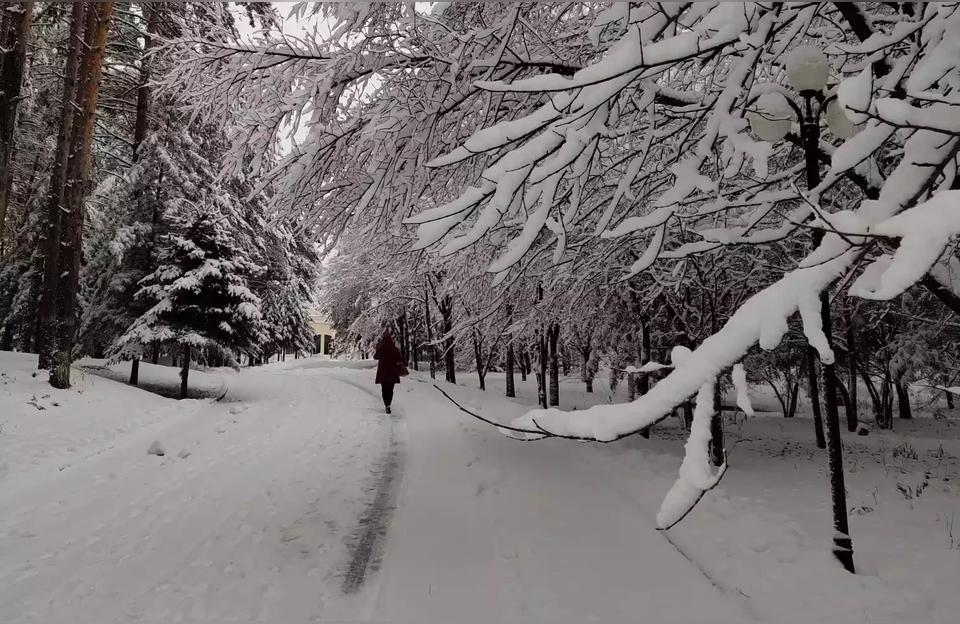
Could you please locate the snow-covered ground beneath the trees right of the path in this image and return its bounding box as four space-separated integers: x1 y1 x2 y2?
462 374 960 622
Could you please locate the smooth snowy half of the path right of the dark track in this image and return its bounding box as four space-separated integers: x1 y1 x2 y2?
346 376 756 624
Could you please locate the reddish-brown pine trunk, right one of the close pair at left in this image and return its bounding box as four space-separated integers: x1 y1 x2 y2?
50 1 113 388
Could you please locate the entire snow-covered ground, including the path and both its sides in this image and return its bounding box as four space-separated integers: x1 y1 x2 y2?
0 353 960 624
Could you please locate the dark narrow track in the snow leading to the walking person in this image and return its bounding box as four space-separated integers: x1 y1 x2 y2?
316 375 403 594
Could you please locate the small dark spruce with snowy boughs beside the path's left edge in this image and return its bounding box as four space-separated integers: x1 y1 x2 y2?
110 203 264 398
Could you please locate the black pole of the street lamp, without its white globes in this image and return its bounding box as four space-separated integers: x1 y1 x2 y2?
800 91 855 573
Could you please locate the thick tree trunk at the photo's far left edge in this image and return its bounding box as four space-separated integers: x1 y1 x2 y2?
0 2 33 241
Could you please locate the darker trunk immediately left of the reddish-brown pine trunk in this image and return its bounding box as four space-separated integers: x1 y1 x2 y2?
36 2 87 370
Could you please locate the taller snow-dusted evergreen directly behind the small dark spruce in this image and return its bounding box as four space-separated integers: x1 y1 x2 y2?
81 102 246 360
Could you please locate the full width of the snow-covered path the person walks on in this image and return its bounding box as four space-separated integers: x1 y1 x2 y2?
0 364 750 624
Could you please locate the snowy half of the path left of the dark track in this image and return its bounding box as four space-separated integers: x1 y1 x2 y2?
0 360 389 624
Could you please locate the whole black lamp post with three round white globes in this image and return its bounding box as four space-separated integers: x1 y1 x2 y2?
750 46 857 572
